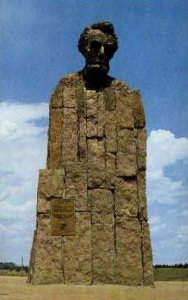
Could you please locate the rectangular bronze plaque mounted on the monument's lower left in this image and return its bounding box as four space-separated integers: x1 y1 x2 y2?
51 198 76 235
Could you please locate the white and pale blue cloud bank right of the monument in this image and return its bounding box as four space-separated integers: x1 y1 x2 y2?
147 129 188 264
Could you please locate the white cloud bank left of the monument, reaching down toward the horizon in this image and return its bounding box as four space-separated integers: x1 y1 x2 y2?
0 102 48 260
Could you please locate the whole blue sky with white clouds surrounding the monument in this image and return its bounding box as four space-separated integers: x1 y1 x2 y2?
0 0 188 263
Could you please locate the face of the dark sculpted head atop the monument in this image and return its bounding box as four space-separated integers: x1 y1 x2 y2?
84 29 115 74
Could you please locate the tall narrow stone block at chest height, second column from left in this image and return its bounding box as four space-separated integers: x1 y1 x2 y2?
61 108 78 162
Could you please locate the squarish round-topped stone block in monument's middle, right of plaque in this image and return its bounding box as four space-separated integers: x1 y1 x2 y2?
88 189 114 224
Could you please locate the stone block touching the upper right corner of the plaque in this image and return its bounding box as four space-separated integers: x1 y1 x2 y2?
65 162 90 211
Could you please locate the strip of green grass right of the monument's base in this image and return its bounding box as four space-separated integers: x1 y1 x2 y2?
154 268 188 281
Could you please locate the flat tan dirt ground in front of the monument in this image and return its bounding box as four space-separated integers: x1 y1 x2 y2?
0 276 188 300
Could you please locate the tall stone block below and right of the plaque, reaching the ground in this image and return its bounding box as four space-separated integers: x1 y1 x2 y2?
63 212 92 284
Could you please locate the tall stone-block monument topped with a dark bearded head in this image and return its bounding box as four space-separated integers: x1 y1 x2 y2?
28 22 153 286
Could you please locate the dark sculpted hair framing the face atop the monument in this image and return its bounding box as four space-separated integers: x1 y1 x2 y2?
78 22 118 55
